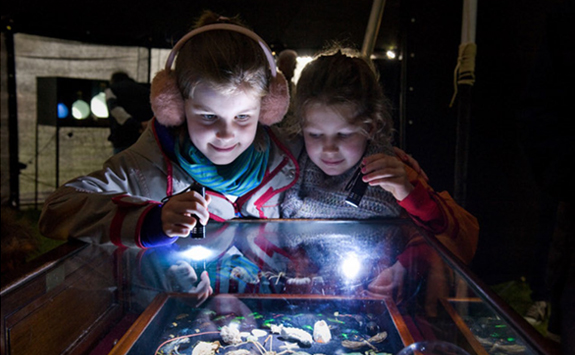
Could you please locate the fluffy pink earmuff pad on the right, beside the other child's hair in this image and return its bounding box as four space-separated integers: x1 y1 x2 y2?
259 73 290 126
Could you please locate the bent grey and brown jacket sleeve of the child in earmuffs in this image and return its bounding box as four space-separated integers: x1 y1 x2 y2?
39 145 171 247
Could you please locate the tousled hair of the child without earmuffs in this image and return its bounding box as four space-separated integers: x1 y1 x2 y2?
292 48 393 145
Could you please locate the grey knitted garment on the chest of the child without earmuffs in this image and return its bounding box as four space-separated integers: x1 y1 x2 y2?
281 143 401 219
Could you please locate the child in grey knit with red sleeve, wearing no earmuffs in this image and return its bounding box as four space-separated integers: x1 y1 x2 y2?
281 49 479 287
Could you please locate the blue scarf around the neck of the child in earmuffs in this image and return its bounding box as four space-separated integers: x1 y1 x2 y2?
175 132 270 196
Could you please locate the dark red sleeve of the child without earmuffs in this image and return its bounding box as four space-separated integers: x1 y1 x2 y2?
399 166 479 263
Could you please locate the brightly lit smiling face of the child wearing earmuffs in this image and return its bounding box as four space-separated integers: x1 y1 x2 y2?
186 84 261 165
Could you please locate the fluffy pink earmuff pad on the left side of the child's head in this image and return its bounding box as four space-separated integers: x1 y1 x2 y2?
150 69 186 127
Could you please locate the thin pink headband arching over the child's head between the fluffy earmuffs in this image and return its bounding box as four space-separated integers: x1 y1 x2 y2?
166 23 277 78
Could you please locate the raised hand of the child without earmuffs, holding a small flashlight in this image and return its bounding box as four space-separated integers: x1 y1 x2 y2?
361 153 413 201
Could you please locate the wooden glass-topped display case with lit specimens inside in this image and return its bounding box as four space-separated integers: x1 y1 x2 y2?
2 219 553 355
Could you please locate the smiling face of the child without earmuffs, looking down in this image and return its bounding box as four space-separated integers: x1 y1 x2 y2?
303 104 367 176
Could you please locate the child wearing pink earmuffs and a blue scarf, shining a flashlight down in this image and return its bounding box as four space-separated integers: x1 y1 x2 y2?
40 12 299 247
